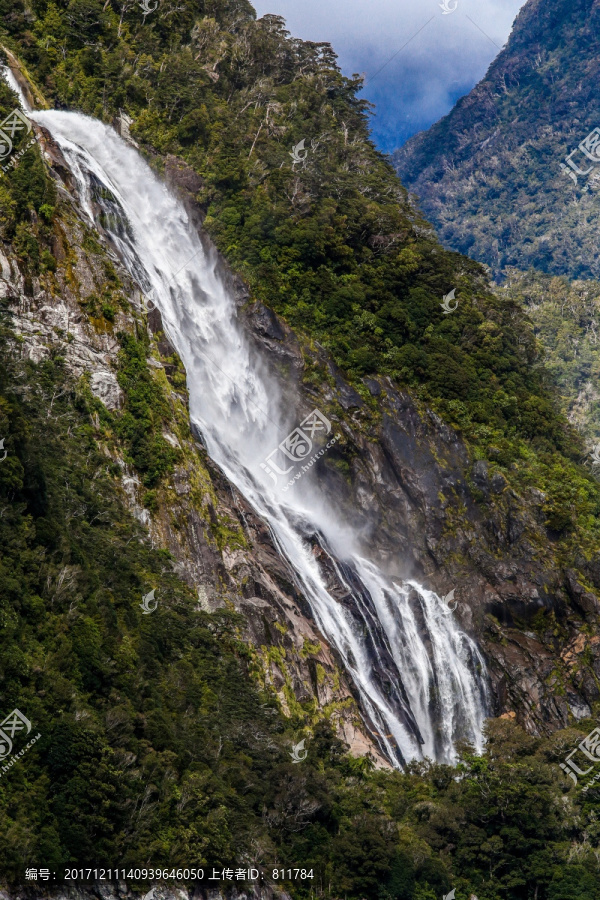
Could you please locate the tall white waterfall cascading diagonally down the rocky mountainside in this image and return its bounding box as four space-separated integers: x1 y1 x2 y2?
16 93 487 765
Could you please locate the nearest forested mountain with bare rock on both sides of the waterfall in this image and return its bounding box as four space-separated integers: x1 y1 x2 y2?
0 0 600 900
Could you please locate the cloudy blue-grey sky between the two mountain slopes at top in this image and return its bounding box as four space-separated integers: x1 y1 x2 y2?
253 0 524 152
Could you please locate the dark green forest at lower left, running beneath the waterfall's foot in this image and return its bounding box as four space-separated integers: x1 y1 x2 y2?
0 318 600 900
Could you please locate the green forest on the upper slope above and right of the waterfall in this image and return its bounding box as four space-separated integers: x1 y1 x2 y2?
0 0 571 451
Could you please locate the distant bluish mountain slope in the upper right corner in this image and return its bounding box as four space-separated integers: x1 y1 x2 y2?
393 0 600 278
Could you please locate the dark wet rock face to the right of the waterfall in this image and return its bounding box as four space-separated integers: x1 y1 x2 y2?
245 288 600 733
